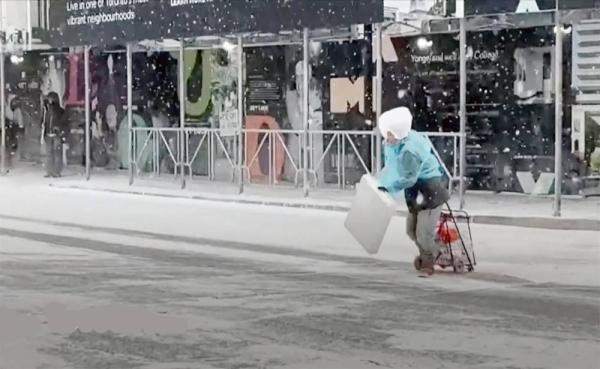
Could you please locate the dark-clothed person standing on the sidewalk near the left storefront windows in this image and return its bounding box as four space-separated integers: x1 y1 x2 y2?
41 92 66 178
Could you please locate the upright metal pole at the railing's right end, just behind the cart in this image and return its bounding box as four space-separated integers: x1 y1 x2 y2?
454 17 467 210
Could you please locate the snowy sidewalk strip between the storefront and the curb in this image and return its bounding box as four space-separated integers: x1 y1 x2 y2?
10 172 600 230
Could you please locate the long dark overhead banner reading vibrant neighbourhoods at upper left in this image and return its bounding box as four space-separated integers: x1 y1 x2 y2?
50 0 383 47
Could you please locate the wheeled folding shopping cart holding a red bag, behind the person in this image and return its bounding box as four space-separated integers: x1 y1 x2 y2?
414 204 477 273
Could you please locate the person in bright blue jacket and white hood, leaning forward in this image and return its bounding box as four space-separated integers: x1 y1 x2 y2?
378 107 450 276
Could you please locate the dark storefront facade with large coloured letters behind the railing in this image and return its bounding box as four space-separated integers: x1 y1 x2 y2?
5 0 600 198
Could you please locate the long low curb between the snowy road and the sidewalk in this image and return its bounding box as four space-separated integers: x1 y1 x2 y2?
49 183 600 231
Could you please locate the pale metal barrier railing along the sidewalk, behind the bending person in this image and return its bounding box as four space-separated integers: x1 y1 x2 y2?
130 127 460 194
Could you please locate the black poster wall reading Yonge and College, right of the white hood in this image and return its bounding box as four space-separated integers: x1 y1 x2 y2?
382 27 571 193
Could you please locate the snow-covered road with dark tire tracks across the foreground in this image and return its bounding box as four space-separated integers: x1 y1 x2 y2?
0 184 600 369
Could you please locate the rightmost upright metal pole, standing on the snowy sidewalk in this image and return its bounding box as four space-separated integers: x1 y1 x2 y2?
554 10 563 217
